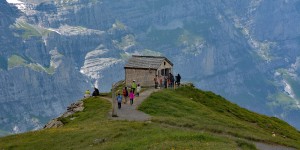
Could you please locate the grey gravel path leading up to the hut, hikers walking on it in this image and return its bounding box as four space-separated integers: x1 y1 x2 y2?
105 88 159 121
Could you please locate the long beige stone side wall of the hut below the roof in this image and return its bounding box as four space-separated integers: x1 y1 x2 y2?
125 68 156 87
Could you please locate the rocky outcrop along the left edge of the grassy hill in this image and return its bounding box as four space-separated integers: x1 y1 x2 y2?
44 101 84 129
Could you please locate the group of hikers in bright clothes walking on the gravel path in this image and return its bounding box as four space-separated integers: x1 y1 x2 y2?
116 80 142 109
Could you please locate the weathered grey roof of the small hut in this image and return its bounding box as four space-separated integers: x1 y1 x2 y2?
124 55 173 69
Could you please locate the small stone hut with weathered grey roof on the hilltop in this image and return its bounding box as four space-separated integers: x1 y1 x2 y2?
124 55 173 87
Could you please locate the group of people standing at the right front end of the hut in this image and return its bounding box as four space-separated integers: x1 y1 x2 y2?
154 73 181 89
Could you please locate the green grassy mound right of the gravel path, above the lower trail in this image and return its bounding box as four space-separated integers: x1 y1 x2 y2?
139 88 300 148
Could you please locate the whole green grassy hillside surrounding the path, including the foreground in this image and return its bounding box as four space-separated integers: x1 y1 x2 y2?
0 87 300 149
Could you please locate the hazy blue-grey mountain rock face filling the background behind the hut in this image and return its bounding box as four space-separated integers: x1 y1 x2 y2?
0 0 300 133
